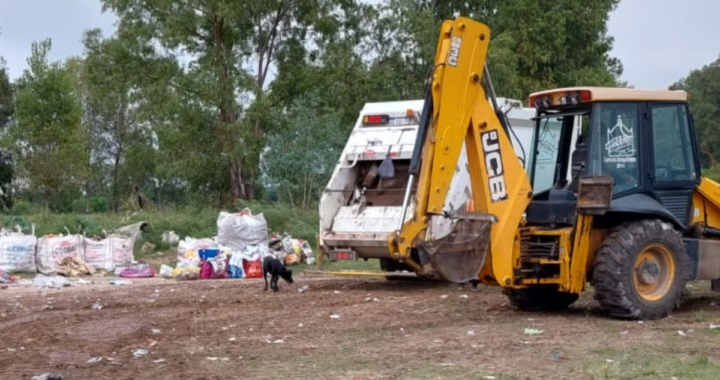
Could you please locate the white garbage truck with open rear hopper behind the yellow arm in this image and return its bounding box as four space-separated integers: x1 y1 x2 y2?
318 98 572 272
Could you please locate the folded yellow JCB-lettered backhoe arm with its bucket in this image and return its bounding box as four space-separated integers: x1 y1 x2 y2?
388 17 532 282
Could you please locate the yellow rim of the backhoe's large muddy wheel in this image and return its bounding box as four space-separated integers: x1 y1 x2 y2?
633 244 675 302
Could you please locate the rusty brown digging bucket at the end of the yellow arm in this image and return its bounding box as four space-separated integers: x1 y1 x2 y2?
420 212 497 283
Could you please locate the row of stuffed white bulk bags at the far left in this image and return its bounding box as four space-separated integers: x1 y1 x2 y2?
0 222 145 282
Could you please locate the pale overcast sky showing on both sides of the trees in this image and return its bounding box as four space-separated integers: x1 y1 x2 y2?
0 0 720 88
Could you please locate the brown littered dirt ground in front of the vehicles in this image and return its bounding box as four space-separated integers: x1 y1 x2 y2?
0 275 720 380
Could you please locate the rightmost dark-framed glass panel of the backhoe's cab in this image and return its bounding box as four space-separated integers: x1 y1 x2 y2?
646 102 699 225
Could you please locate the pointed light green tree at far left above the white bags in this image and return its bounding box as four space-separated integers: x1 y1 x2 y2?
4 40 87 212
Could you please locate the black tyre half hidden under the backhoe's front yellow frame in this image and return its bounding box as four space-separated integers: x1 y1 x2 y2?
503 285 579 311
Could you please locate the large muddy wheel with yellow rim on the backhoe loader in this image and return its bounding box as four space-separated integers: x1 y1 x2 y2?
593 220 689 319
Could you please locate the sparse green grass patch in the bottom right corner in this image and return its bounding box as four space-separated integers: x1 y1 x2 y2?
584 347 720 380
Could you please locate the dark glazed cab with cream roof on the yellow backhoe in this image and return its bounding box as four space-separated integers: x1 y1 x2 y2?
527 87 700 227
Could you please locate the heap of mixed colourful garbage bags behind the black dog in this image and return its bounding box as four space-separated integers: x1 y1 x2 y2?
160 208 315 280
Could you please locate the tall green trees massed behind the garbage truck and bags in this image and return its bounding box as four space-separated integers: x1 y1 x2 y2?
0 0 622 209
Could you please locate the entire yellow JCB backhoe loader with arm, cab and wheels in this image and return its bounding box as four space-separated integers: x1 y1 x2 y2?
388 17 720 319
